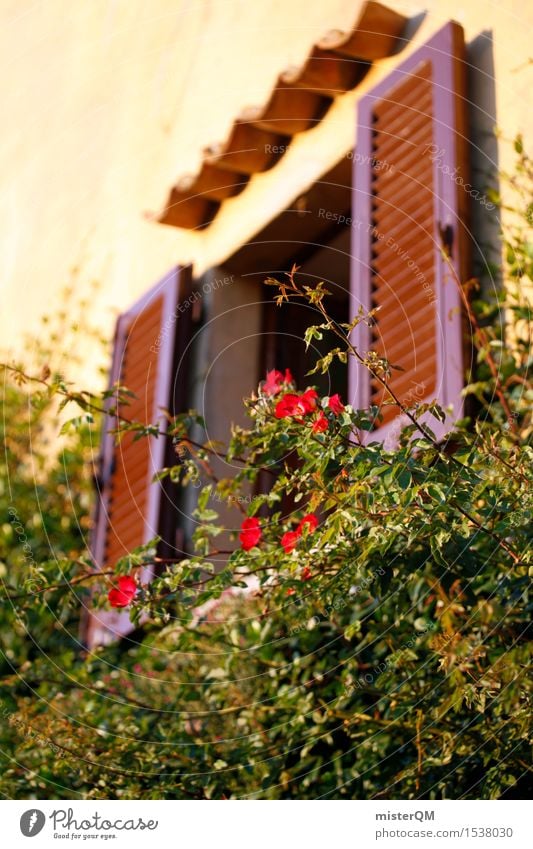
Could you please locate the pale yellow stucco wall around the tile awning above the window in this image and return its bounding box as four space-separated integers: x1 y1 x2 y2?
0 0 533 360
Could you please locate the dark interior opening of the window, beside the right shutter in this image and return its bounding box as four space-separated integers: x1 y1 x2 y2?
224 156 352 398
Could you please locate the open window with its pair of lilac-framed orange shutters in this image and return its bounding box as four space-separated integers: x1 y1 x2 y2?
87 18 468 645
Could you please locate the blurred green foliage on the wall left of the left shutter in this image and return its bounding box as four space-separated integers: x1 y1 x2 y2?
0 289 105 774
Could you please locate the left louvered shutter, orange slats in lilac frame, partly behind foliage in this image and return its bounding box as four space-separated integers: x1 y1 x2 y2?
85 269 190 646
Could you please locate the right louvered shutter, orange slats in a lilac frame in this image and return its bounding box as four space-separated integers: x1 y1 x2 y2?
350 22 469 443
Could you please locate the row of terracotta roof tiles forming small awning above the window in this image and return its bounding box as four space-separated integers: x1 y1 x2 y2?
159 0 407 229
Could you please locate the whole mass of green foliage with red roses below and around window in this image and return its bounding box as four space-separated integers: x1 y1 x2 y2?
1 151 533 799
